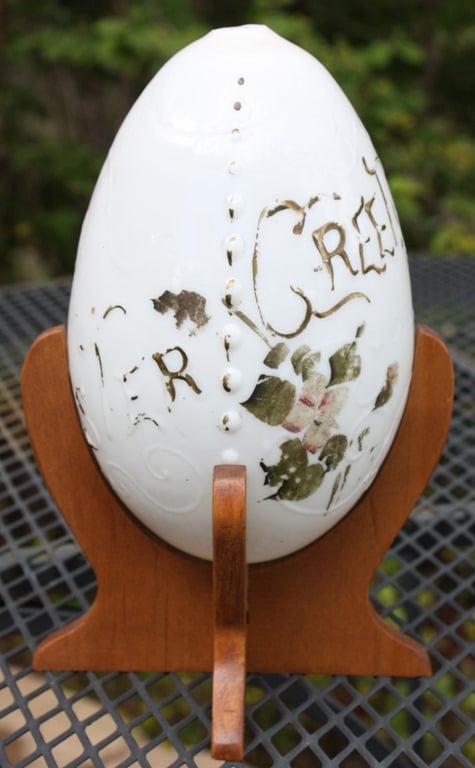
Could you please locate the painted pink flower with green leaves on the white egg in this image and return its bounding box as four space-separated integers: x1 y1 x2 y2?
242 325 398 506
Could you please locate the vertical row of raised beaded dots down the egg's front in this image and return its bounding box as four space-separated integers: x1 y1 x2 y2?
222 77 245 463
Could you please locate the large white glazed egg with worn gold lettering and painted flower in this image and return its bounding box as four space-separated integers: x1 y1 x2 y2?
68 26 413 562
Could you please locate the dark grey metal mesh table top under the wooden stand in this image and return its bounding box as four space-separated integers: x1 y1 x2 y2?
0 256 475 768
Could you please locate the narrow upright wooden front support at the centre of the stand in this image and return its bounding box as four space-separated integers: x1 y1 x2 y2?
211 466 247 760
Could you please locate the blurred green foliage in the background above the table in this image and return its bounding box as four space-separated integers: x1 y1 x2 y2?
0 0 475 281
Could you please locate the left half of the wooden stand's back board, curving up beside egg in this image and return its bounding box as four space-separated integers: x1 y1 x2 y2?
22 326 213 672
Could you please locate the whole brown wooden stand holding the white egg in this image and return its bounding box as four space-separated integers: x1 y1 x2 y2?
22 326 453 760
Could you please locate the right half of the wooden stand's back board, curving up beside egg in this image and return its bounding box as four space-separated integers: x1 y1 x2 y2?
248 326 454 677
